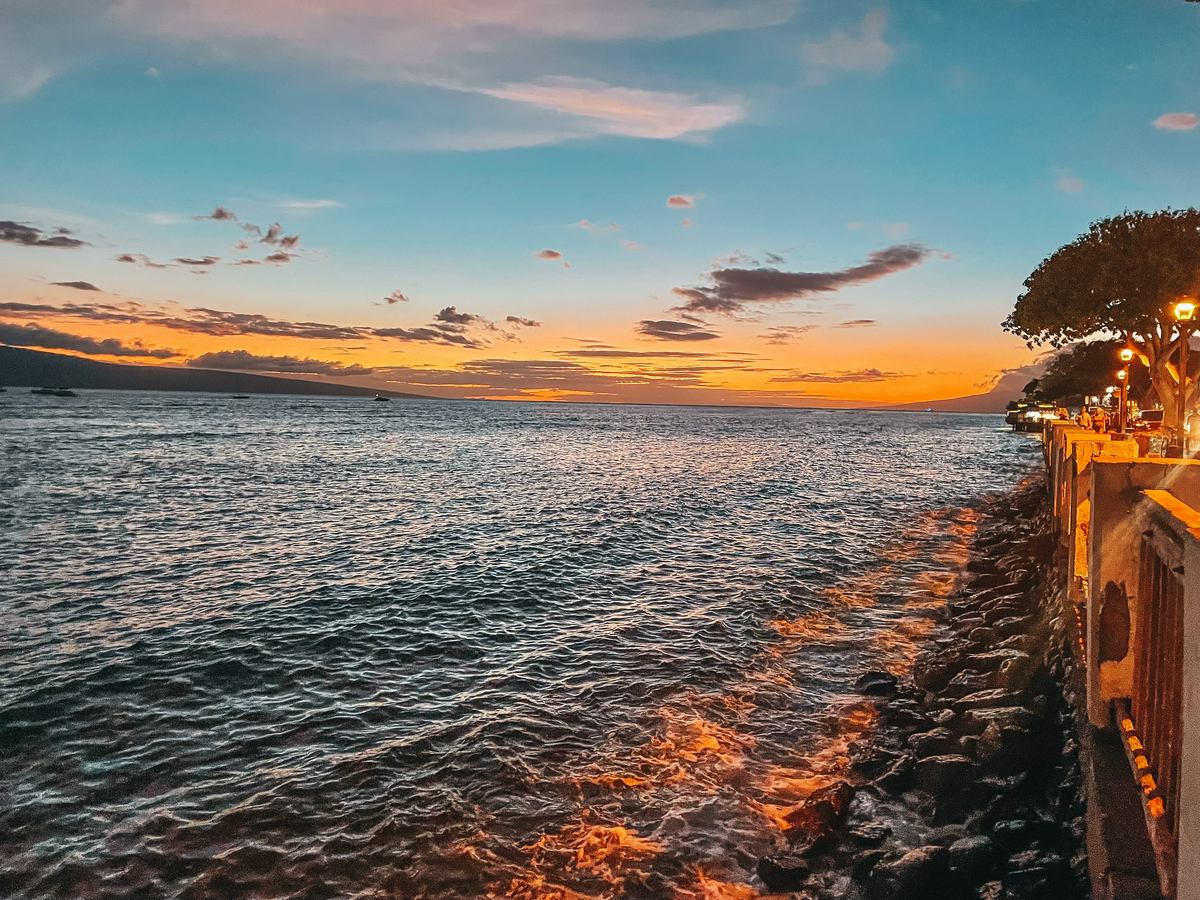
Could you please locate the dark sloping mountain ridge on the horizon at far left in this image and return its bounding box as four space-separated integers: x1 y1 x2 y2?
0 346 430 400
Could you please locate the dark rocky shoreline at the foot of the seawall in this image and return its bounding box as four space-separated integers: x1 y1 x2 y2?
757 480 1090 900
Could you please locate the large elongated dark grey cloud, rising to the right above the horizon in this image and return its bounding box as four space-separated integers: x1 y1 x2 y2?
672 244 934 316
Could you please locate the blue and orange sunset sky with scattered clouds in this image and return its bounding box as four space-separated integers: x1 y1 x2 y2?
0 0 1200 406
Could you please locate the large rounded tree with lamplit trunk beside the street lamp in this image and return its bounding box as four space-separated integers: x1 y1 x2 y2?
1003 209 1200 425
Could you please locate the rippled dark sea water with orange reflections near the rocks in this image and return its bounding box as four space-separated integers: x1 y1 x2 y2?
0 390 1034 898
